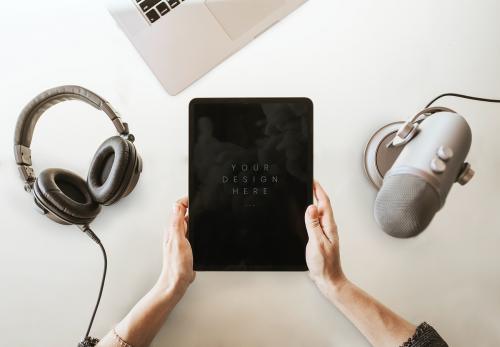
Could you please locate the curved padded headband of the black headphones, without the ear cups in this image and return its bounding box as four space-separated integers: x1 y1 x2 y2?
14 85 129 183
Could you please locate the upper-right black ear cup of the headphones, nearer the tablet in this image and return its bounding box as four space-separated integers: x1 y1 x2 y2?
87 136 139 205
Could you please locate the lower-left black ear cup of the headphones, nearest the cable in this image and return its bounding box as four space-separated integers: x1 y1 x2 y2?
34 169 101 225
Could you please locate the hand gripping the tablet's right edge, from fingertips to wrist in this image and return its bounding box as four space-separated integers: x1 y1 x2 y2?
305 182 347 296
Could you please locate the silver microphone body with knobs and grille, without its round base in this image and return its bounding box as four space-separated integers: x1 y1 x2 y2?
374 112 473 238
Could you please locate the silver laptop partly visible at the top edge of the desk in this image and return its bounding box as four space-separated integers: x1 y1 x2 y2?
108 0 307 95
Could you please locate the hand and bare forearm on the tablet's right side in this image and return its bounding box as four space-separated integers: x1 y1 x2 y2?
305 182 424 347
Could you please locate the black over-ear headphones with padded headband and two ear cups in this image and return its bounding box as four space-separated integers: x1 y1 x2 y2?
14 86 142 226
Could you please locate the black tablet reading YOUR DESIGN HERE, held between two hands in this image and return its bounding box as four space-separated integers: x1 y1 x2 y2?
188 98 313 271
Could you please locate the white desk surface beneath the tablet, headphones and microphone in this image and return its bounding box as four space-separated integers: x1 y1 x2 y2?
0 0 500 347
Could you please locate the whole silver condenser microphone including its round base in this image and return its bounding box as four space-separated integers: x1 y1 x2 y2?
365 108 474 238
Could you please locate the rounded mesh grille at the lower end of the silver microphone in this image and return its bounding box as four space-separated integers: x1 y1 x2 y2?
375 175 441 238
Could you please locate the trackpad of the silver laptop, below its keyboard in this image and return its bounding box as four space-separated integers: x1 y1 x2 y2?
206 0 286 40
